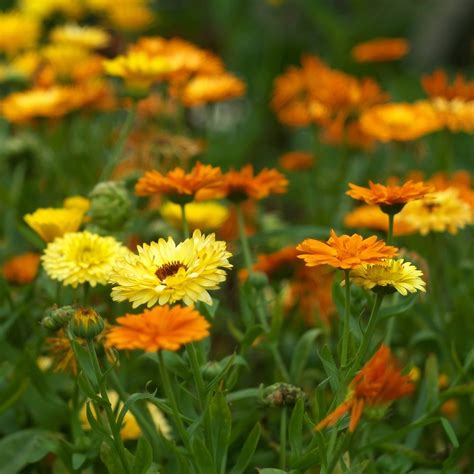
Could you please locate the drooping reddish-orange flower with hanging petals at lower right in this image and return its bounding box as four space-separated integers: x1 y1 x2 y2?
315 345 415 433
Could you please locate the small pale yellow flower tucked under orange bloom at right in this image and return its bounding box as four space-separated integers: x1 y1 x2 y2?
350 258 426 296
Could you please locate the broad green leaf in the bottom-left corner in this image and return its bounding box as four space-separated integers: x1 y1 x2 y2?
0 429 60 474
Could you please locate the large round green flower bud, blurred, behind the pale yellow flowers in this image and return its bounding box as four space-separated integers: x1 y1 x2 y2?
88 181 131 232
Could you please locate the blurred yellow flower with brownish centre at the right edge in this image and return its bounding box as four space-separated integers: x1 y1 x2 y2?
398 188 472 235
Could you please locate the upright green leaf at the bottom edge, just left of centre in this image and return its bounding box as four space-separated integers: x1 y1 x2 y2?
208 392 232 472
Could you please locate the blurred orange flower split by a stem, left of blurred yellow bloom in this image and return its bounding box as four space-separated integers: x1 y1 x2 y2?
344 205 414 236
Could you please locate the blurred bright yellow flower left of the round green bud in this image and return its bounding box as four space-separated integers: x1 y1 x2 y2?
23 207 84 242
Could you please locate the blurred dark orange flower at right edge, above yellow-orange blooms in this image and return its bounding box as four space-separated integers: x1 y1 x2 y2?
421 69 474 101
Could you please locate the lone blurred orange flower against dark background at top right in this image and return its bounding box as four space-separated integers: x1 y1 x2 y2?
352 38 410 63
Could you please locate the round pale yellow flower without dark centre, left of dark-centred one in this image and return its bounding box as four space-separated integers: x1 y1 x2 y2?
41 231 129 288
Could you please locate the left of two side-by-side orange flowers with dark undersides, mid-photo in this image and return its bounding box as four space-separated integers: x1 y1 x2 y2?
135 162 222 202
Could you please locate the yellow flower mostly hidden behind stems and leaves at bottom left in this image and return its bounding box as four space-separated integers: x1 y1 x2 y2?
79 391 171 440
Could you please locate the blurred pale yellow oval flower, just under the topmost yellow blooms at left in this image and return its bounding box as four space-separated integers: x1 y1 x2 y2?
49 23 110 49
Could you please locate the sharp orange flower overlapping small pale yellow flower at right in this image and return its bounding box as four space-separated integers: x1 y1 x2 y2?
296 230 398 270
